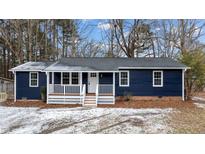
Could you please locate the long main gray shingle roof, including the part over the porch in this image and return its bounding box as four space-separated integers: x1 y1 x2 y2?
44 58 186 71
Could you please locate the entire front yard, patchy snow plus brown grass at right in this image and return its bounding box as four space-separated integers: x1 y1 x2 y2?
0 102 205 134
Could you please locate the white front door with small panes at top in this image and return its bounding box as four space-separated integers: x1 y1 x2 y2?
88 73 98 93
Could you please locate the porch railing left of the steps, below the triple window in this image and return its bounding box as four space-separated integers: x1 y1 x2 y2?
49 84 81 94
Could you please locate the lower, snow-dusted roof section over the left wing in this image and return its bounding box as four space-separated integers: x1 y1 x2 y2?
10 62 53 71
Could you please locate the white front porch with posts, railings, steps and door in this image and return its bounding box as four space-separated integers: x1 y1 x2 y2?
46 72 115 106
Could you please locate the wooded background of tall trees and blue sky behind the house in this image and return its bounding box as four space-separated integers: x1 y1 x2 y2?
0 19 205 78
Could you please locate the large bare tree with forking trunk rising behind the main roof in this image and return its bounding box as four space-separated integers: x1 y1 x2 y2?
113 19 152 57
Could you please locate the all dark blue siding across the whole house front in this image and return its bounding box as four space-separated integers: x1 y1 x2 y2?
16 70 182 99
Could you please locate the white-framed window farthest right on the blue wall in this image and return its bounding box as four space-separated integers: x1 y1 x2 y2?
153 71 163 87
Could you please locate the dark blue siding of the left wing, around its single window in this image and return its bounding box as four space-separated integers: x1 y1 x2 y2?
16 72 46 99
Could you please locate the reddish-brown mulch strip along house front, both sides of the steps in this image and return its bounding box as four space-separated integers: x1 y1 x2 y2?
1 100 196 109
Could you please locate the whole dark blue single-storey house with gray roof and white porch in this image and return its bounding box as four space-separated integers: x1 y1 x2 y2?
10 58 187 105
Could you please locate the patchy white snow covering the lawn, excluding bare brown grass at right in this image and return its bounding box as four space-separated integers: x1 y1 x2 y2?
0 106 172 134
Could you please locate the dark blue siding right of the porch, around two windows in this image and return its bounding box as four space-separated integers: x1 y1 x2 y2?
115 70 182 96
